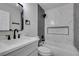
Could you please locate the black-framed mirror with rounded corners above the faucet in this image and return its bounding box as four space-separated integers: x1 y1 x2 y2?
0 3 23 31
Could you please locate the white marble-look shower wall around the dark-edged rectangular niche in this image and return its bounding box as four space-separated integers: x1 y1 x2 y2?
45 4 74 45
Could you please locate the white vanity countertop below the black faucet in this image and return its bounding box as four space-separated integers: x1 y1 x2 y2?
0 36 39 56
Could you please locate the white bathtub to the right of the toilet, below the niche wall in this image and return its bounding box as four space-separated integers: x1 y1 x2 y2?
44 43 79 56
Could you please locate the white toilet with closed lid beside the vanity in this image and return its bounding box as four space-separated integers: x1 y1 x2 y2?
38 46 51 56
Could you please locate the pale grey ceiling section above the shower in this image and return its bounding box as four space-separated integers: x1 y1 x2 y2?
39 3 68 10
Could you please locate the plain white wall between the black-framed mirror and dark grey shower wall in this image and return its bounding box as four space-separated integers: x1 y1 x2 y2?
23 3 38 36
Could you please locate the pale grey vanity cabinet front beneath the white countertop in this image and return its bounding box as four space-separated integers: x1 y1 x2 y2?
4 41 38 56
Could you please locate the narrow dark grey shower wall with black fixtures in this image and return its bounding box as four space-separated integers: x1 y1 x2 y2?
38 5 45 45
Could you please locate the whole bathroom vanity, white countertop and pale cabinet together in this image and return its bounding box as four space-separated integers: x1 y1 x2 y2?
0 37 39 56
